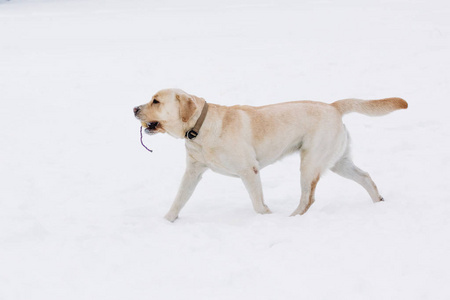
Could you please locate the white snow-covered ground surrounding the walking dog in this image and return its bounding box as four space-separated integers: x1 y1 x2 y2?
0 0 450 300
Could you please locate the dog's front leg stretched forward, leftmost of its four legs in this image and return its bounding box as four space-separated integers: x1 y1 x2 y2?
165 159 207 222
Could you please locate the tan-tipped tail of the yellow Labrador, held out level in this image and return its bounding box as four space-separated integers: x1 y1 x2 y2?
331 98 408 117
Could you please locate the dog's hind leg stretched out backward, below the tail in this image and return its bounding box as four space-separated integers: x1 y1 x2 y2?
331 155 384 203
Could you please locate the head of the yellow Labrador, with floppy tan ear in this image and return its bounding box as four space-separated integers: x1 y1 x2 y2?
133 89 202 138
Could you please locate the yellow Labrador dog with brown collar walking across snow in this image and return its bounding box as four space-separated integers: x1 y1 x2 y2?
133 89 408 222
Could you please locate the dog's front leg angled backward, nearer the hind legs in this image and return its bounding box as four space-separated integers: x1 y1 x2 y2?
240 167 271 214
